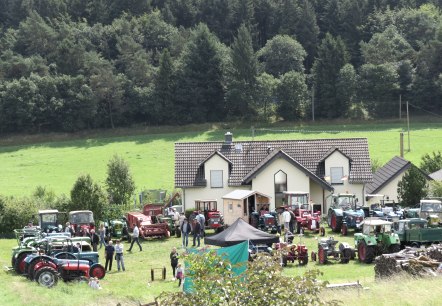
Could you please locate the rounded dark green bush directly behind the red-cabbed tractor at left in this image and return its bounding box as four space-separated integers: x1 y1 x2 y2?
72 174 107 220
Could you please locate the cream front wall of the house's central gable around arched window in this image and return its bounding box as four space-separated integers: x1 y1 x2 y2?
252 158 310 210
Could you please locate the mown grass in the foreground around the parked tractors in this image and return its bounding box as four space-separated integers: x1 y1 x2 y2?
0 231 442 306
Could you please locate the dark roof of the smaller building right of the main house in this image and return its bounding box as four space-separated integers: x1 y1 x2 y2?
365 156 411 194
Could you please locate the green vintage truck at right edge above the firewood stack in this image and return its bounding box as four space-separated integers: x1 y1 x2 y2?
393 218 442 248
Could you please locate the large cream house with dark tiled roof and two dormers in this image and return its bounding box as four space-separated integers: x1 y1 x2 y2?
175 132 373 213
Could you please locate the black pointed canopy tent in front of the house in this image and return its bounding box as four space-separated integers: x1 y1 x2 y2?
204 218 279 247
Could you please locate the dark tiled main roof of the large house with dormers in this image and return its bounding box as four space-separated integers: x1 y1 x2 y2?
175 138 373 188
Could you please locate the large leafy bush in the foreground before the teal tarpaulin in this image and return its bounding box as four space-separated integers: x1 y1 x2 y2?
157 251 338 306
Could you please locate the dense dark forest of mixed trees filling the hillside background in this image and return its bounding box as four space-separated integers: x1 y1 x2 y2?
0 0 442 133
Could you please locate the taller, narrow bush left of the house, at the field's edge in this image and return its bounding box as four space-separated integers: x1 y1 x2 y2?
106 155 135 205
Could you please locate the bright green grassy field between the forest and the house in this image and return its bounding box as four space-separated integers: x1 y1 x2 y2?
0 120 442 196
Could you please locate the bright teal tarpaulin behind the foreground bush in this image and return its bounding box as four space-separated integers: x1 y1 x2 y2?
183 241 249 293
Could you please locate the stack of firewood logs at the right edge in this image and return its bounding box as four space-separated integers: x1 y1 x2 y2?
374 245 442 278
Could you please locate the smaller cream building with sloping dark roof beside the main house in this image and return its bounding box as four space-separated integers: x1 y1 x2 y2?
365 156 431 205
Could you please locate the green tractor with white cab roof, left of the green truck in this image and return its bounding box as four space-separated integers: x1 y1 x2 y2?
354 218 401 263
